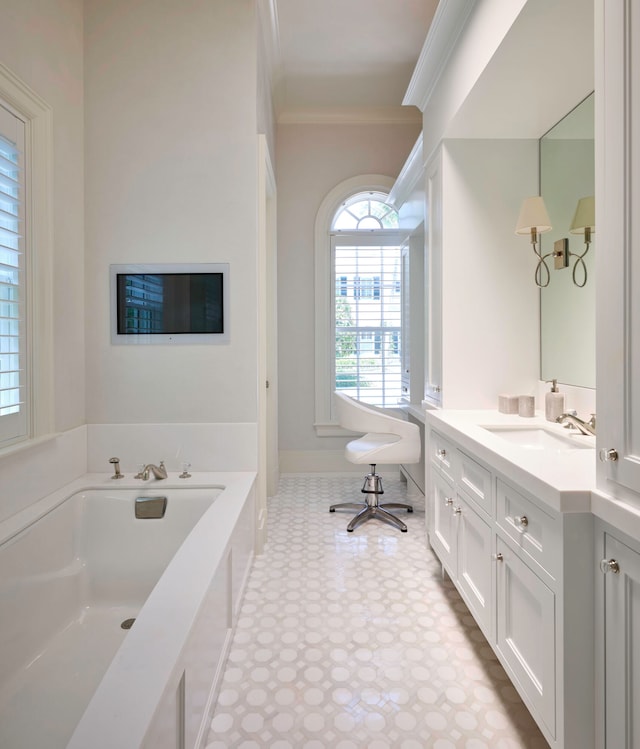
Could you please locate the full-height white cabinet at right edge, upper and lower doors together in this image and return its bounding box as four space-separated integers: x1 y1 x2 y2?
593 5 640 749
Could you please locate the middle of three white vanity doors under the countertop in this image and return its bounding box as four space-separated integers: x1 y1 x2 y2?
454 495 493 640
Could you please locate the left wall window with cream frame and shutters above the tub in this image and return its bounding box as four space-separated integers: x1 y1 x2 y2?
0 63 53 451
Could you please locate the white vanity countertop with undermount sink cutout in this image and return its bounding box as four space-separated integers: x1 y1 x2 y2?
425 410 596 512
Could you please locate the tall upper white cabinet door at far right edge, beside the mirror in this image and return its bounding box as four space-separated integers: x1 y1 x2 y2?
596 0 640 505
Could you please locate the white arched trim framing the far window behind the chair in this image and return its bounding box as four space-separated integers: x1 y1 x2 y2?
314 174 396 437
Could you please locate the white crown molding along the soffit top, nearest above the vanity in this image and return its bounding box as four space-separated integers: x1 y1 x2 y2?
402 0 479 112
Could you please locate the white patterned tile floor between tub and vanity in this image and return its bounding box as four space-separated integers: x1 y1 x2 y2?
206 474 548 749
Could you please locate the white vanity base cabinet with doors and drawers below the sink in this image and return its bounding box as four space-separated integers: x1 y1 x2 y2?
427 414 596 749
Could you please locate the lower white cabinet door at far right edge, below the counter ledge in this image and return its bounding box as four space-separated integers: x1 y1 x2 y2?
604 534 640 749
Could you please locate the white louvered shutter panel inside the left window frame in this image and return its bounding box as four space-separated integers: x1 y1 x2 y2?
0 104 28 444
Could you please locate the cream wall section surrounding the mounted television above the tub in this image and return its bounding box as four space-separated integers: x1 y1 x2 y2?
85 0 257 424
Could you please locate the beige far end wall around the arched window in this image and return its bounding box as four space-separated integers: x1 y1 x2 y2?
276 124 419 470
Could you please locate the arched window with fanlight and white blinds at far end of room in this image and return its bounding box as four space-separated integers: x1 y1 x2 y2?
316 178 403 435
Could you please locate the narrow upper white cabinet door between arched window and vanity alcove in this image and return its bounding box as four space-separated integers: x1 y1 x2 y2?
424 154 442 405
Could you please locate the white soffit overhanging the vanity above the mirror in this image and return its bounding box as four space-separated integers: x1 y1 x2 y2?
423 0 593 158
